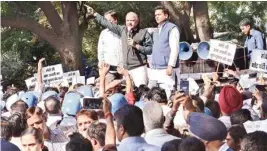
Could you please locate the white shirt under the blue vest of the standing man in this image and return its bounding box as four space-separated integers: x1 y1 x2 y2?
159 26 180 67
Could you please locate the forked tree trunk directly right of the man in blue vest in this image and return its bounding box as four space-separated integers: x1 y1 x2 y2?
161 1 194 43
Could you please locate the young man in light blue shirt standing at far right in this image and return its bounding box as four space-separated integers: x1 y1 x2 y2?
239 18 266 57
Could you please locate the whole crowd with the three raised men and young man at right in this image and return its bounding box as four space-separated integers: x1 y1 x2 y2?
1 6 267 151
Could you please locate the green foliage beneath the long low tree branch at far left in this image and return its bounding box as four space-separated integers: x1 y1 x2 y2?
1 29 60 87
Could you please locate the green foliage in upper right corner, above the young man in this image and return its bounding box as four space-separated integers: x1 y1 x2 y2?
209 1 267 32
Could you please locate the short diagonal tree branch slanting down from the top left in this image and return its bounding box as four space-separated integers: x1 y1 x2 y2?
38 1 62 35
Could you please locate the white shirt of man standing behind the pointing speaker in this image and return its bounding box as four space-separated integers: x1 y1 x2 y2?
98 29 123 66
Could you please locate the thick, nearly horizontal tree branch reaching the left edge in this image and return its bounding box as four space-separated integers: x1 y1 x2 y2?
1 16 59 48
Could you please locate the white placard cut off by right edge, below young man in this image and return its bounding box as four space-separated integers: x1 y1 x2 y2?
249 49 267 72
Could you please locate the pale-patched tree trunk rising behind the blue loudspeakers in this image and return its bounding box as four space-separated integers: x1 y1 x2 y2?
193 1 213 41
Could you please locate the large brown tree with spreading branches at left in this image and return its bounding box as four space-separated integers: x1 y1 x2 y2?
1 1 89 74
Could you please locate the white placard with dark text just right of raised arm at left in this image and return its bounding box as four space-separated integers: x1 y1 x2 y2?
42 64 63 86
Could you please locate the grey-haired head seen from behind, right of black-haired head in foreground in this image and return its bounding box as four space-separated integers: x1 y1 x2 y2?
143 101 164 132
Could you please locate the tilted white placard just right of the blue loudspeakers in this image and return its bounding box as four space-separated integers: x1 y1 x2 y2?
208 39 236 66
